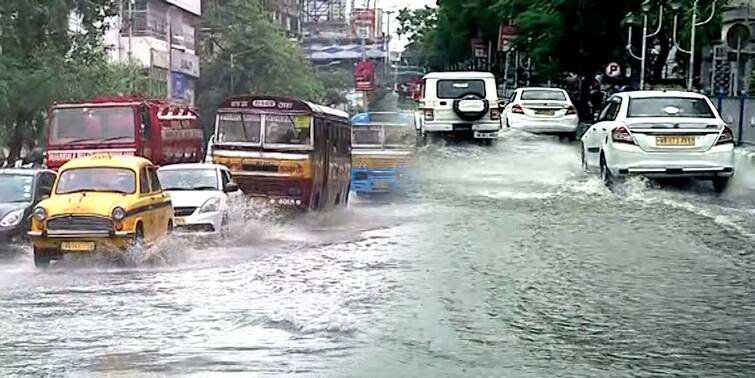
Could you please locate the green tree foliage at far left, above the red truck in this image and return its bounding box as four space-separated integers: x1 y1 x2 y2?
0 0 154 160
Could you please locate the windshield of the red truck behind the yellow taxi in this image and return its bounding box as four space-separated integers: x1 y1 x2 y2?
49 106 136 145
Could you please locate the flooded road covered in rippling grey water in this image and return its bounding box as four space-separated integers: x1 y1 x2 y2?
0 133 755 377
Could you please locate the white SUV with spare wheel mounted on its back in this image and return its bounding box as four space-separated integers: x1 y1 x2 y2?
419 72 501 140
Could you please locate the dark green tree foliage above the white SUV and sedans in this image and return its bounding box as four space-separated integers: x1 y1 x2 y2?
398 0 727 84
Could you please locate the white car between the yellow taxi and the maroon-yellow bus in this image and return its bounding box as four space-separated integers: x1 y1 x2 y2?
157 164 243 235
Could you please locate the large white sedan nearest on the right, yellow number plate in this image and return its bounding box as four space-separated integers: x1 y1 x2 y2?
581 91 734 192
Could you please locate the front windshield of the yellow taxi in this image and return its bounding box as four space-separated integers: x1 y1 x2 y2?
55 167 136 194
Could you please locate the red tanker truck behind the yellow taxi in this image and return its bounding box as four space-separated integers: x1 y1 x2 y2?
45 96 204 169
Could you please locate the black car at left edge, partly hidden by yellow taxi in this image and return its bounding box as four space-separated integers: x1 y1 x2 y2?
0 168 56 242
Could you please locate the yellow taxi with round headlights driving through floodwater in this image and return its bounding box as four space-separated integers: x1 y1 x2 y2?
29 155 173 267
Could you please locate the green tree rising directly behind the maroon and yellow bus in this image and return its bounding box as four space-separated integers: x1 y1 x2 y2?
198 0 324 134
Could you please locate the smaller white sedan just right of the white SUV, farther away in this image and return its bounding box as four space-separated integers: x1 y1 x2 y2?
502 88 579 138
